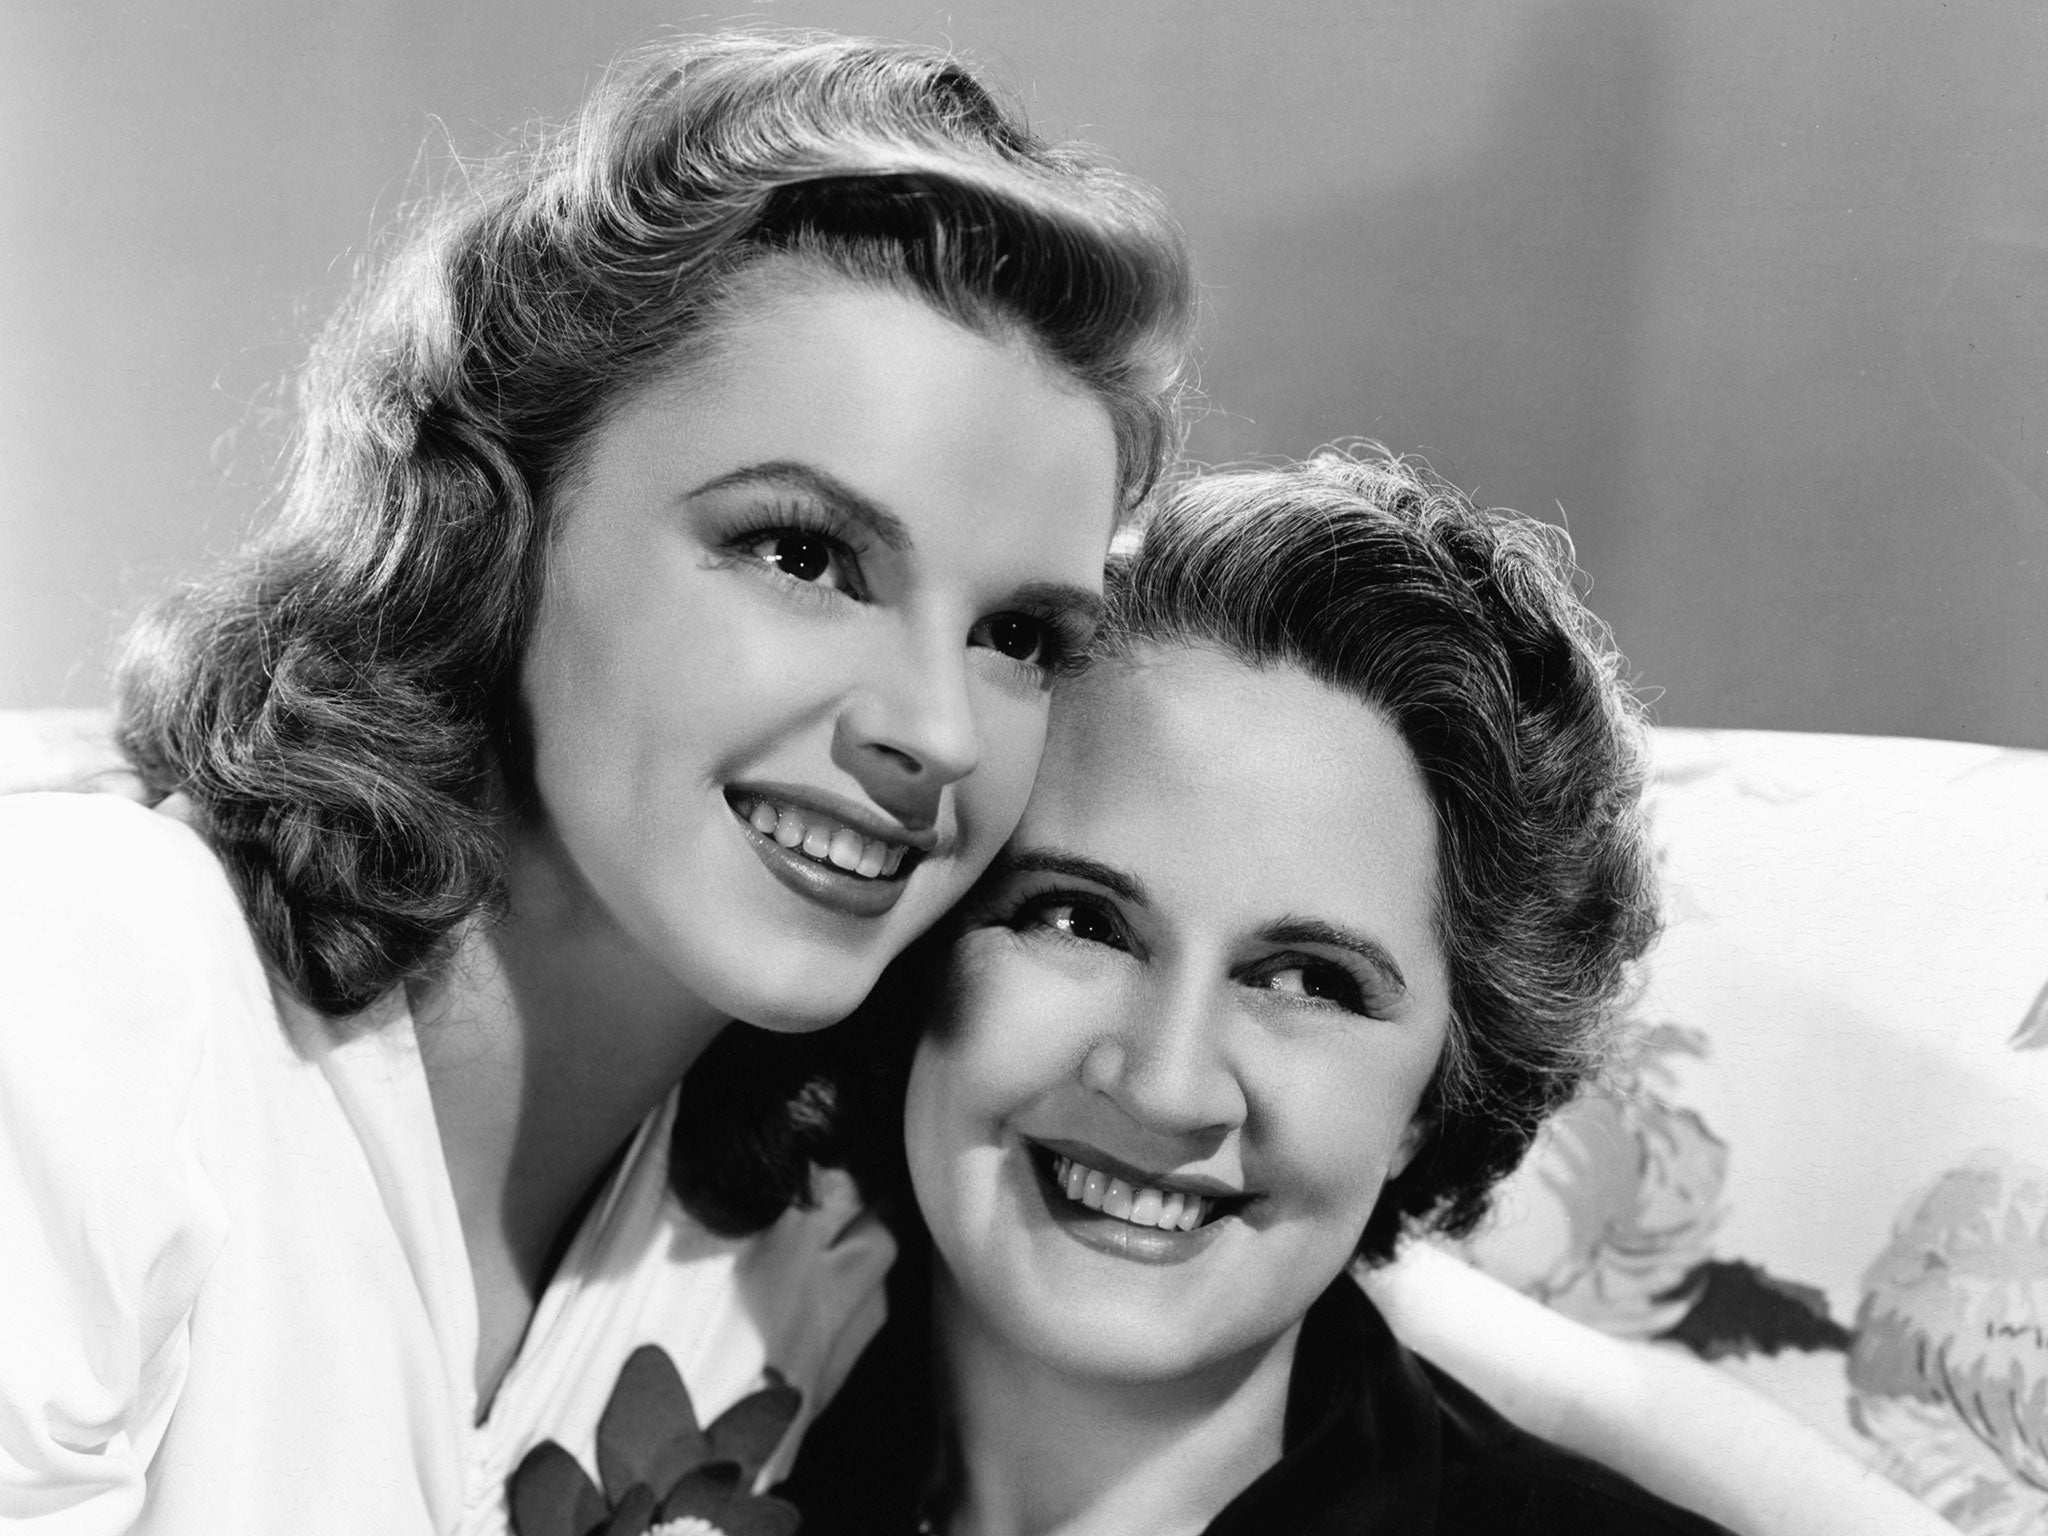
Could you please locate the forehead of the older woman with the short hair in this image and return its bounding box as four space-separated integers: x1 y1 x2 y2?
1018 645 1436 942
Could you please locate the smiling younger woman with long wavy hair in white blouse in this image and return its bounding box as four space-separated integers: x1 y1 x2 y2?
0 37 1192 1536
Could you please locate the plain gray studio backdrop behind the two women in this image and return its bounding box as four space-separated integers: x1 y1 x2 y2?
0 0 2048 748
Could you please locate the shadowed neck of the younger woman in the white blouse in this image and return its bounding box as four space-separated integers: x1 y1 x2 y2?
410 827 725 1399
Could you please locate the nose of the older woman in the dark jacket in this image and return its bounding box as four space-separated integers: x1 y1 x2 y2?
1081 975 1247 1143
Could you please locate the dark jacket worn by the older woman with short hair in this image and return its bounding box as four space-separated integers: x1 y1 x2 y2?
780 1253 1726 1536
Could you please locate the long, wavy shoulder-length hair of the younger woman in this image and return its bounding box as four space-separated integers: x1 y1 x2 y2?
119 33 1192 1018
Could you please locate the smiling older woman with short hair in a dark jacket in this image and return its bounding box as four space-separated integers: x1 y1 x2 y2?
784 459 1931 1536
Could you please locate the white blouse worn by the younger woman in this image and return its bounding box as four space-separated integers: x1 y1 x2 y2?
0 795 893 1536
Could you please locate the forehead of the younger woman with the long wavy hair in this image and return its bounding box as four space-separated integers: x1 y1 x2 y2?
569 264 1116 573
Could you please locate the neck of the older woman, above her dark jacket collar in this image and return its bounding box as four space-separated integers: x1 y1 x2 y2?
934 1266 1300 1536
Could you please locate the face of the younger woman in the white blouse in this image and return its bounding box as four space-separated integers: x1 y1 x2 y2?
522 281 1116 1030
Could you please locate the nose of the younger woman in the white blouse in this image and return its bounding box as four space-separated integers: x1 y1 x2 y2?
834 633 981 817
